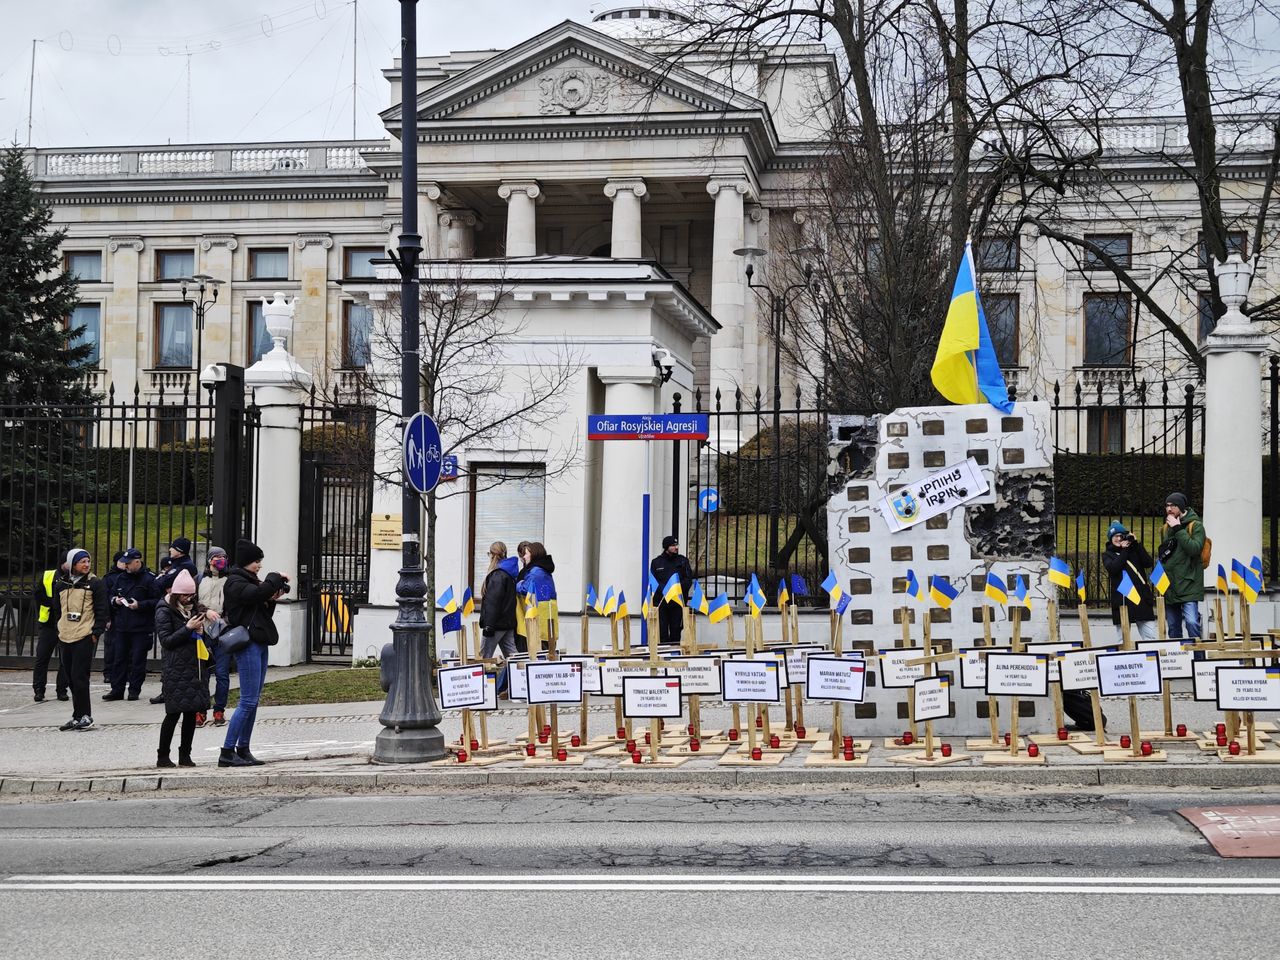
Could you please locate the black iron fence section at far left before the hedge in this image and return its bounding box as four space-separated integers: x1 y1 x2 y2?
0 384 257 664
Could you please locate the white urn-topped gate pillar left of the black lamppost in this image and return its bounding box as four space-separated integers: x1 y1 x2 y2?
244 293 311 666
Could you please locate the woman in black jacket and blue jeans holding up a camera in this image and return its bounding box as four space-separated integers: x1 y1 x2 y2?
218 540 289 767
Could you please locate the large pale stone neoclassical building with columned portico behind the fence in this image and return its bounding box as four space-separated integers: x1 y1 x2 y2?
31 4 1274 653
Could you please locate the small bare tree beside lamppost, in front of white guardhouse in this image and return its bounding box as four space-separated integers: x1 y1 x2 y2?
325 262 581 660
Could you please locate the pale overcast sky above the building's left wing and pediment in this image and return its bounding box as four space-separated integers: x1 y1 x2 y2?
0 0 593 147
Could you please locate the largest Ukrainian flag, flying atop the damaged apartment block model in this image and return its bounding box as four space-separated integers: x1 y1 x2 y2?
931 242 1014 413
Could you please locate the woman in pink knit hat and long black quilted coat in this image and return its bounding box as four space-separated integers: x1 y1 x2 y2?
155 571 218 767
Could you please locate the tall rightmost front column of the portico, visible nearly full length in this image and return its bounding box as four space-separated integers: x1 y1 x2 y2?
707 177 750 402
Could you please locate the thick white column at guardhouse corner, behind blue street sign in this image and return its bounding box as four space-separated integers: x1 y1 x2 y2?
596 366 666 601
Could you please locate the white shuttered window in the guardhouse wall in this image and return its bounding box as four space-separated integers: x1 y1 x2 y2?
467 463 547 596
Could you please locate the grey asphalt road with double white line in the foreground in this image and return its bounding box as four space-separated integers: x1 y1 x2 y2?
0 790 1280 960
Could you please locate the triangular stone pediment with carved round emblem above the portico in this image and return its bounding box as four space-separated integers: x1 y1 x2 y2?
383 20 769 136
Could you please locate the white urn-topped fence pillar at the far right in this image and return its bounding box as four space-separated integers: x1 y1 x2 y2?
1193 253 1270 586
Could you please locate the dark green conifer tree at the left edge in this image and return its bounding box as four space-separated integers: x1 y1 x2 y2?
0 147 93 576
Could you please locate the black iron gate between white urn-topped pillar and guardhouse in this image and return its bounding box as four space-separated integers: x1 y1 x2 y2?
298 396 374 662
